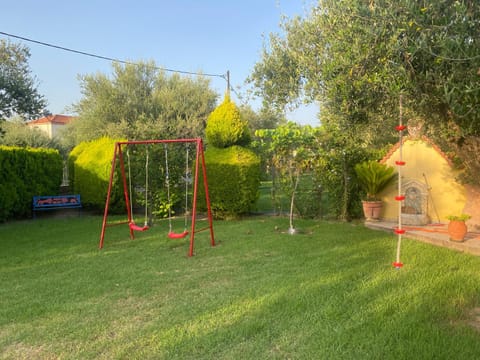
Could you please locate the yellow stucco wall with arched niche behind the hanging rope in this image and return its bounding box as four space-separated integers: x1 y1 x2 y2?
380 139 467 223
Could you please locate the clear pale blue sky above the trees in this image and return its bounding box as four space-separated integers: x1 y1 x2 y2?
0 0 318 125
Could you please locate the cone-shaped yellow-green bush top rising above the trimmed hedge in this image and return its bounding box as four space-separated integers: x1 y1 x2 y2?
205 94 251 148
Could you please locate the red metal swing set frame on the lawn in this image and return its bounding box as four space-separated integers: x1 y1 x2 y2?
99 138 215 256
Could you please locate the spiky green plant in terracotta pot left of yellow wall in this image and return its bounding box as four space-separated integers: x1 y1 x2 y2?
355 160 395 221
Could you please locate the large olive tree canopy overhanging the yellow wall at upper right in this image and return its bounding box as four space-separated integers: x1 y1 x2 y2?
250 0 480 155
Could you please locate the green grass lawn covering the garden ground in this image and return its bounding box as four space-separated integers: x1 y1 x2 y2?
0 216 480 359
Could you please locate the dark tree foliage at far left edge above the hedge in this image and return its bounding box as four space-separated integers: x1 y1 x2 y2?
0 39 46 120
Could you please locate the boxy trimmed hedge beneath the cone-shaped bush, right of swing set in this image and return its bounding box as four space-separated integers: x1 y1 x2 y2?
199 146 260 218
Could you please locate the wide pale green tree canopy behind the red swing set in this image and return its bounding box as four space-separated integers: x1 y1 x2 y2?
73 62 217 143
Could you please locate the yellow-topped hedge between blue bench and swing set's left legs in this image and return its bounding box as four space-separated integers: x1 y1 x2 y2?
69 137 124 210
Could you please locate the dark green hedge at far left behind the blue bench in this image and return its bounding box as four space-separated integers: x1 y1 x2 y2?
0 146 63 221
